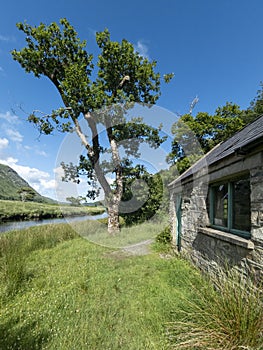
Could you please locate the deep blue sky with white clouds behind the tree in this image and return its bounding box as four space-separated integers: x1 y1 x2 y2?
0 0 263 197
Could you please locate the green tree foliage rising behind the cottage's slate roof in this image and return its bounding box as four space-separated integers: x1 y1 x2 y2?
167 102 245 174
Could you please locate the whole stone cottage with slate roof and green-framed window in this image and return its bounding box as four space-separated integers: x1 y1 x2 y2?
169 116 263 277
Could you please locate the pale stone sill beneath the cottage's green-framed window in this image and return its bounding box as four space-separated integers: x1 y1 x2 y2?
198 227 254 250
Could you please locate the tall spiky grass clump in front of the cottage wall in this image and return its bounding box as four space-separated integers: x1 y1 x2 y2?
168 270 263 350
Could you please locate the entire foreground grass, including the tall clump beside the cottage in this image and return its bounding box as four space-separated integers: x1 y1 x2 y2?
0 221 263 350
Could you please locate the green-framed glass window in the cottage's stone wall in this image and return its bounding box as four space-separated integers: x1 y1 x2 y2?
209 178 250 238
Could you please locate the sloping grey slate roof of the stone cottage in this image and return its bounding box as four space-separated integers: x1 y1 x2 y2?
169 115 263 187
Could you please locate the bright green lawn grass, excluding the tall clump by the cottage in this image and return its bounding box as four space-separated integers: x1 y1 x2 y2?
0 220 203 350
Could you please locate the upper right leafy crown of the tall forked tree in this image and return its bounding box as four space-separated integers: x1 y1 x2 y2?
95 29 160 109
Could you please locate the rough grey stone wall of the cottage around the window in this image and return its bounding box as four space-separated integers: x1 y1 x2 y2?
171 162 263 279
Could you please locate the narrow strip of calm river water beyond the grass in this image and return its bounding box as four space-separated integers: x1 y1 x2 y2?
0 212 107 233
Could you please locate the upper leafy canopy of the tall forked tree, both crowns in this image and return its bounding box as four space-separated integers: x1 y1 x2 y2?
12 19 165 134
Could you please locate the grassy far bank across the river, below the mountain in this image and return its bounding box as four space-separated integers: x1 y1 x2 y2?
0 200 104 222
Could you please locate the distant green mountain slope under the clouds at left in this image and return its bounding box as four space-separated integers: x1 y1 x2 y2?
0 164 55 203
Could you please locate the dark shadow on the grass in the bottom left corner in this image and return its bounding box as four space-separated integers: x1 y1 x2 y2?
0 318 49 350
